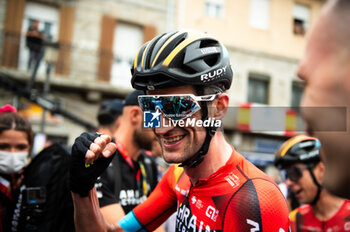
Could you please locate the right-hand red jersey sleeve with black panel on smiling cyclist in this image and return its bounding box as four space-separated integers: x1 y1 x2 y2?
223 178 289 232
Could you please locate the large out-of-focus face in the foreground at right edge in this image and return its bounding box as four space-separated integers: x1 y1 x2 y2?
298 12 350 197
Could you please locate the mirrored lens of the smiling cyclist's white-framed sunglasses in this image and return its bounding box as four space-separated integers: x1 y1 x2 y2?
139 95 200 120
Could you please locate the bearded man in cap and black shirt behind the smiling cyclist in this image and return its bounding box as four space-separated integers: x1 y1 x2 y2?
96 91 165 230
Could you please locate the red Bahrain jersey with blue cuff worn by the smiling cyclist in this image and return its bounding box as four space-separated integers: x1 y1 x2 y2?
119 148 289 232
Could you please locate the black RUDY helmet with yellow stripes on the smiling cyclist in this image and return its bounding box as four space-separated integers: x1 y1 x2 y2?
131 30 232 90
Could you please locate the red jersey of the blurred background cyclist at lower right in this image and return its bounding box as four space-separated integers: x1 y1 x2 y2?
289 200 350 232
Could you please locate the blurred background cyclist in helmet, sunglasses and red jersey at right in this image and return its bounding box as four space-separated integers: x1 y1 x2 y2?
275 135 350 231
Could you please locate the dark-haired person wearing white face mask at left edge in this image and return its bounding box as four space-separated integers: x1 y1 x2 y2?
0 105 33 231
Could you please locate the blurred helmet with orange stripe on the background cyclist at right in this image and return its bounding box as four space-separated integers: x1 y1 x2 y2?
275 135 321 169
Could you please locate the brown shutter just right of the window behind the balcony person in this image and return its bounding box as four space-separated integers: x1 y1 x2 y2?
56 5 75 76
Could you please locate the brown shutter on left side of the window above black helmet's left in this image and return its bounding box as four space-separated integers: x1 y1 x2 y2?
97 15 117 82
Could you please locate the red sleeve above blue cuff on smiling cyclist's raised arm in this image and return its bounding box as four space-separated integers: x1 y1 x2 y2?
129 165 178 231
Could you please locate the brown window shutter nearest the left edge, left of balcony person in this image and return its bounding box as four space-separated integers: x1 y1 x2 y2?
1 0 25 68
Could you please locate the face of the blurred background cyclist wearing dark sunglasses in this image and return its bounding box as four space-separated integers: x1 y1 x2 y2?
286 164 317 204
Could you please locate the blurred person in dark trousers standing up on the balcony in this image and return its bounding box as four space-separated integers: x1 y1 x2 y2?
26 20 45 70
